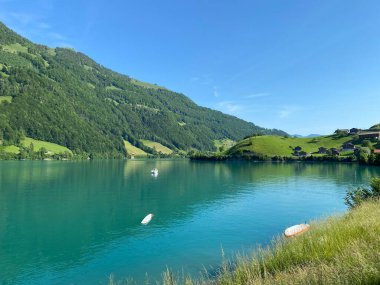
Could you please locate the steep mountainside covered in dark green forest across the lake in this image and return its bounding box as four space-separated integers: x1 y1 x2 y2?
0 23 285 157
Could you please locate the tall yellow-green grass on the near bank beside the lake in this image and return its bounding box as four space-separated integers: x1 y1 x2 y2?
212 201 380 284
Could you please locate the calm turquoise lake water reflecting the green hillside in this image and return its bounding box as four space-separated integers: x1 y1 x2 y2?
0 159 380 284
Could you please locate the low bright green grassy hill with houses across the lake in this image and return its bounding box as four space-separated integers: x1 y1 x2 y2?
228 136 352 156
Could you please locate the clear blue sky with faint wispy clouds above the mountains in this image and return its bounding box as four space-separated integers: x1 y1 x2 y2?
0 0 380 135
